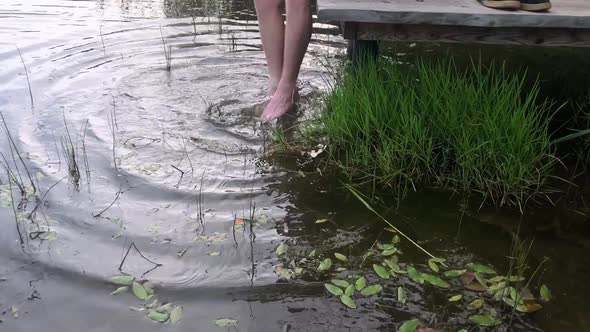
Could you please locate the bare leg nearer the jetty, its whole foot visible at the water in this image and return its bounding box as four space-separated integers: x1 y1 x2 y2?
262 0 312 121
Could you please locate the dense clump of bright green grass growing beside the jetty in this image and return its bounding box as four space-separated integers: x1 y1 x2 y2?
322 60 555 205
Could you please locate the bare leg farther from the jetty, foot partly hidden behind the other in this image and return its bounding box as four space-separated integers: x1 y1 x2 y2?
256 0 285 96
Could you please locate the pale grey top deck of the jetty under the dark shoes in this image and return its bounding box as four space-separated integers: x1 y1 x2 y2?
317 0 590 29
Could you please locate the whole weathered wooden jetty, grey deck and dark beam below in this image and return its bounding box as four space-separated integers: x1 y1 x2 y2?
317 0 590 57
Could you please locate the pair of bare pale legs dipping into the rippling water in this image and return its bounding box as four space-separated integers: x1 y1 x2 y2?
256 0 312 121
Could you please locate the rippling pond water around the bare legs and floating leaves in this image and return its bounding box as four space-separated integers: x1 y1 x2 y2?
0 0 590 331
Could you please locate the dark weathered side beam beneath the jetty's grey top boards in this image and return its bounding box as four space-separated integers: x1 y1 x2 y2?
354 23 590 47
